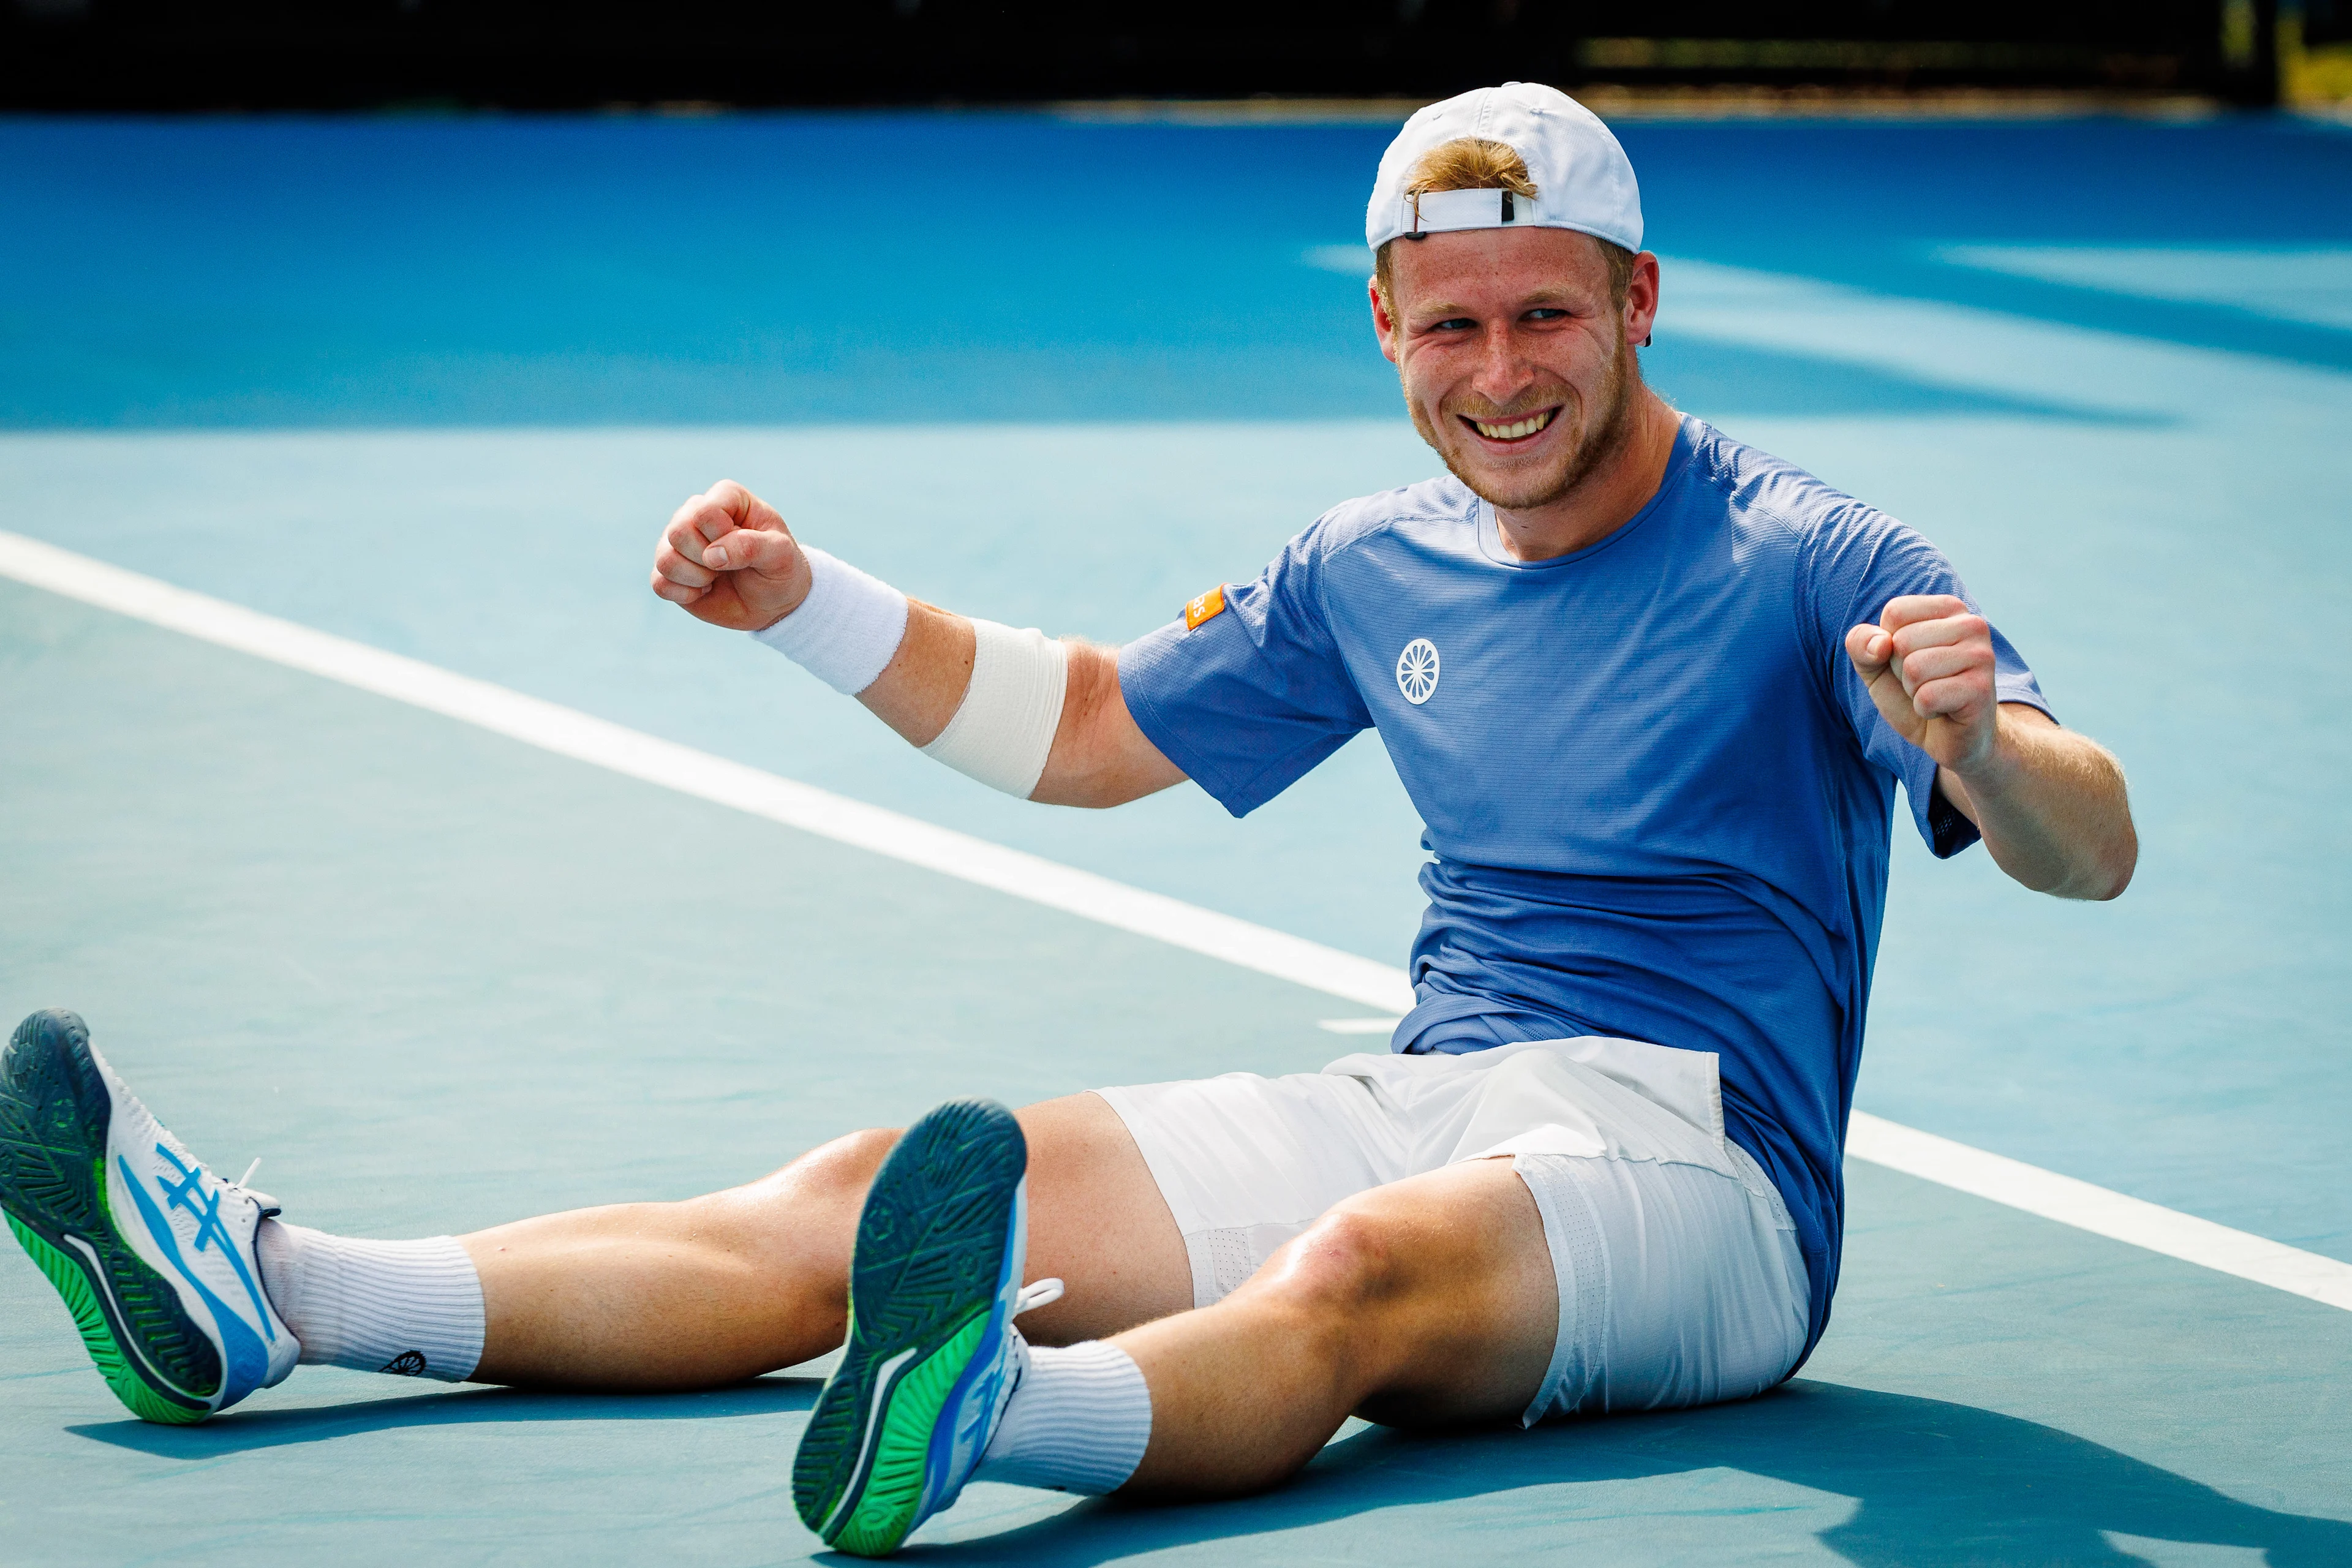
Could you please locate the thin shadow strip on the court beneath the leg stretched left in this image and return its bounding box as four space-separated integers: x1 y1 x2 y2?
68 1378 826 1460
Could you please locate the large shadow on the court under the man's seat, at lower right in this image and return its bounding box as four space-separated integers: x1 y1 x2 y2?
941 1382 2352 1568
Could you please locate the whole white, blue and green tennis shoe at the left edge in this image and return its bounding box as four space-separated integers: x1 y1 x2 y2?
0 1009 301 1425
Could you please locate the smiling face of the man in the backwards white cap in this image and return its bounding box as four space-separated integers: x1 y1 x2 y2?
1371 228 1658 513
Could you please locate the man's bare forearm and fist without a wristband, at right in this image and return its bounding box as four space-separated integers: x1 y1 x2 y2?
1846 595 2140 898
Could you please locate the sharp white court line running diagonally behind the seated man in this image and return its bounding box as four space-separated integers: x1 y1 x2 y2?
0 531 2352 1312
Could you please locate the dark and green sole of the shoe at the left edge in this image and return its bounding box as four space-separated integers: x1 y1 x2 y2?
0 1011 221 1427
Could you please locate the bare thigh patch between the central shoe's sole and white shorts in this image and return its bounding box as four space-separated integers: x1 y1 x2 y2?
1019 1093 1194 1344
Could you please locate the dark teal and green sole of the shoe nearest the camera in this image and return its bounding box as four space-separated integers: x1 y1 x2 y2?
793 1100 1028 1556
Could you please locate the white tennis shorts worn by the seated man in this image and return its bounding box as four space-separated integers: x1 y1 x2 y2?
1098 1037 1806 1427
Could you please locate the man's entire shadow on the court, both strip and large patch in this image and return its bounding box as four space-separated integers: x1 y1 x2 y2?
41 1378 2352 1568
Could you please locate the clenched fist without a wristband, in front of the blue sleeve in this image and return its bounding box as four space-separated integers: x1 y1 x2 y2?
1846 592 1999 776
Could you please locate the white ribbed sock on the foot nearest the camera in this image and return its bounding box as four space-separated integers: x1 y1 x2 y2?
974 1340 1153 1495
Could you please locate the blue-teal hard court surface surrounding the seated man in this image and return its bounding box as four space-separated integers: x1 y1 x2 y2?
0 115 2352 1568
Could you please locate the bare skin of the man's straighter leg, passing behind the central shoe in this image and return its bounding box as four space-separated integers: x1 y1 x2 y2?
463 1093 1194 1389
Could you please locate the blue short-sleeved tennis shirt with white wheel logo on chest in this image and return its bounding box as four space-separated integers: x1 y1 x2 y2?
1120 416 2046 1354
